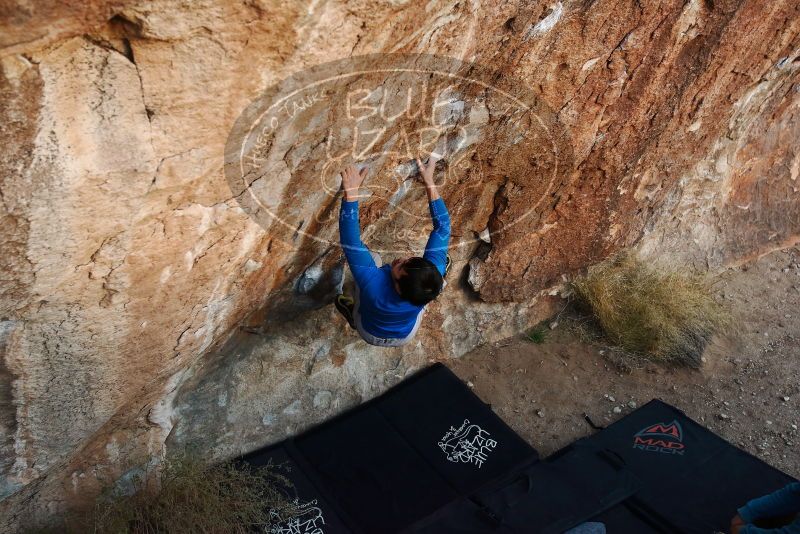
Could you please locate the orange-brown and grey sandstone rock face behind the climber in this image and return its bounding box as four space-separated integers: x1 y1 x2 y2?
0 0 800 529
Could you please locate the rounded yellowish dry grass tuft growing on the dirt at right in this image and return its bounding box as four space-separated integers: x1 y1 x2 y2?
572 254 730 368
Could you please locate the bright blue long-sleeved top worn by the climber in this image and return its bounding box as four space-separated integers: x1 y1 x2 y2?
339 198 450 338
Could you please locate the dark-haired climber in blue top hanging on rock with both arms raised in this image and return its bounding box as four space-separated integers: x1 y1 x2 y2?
334 155 450 347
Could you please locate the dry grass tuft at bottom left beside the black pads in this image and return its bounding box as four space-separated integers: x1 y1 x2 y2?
68 453 295 534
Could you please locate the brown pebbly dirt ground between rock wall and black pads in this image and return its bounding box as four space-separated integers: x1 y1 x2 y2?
446 248 800 478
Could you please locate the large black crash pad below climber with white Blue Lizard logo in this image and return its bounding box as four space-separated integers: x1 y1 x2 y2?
239 364 538 534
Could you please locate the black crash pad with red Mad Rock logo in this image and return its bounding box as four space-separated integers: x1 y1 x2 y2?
578 400 794 533
